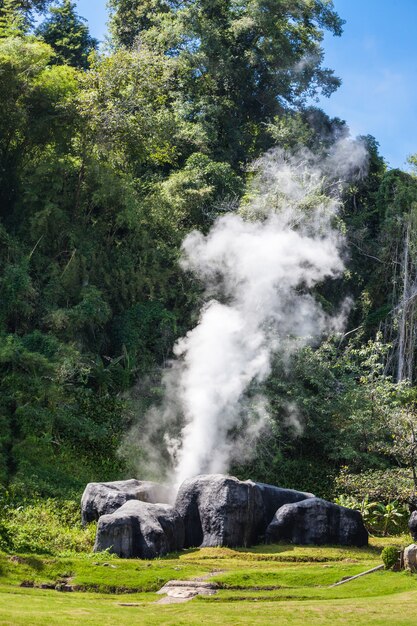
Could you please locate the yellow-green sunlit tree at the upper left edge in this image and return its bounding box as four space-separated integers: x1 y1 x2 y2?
0 37 78 217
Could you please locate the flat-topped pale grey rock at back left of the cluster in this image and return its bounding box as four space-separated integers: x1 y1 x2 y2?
81 479 170 524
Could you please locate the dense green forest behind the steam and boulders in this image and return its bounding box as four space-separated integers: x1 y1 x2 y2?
0 0 417 528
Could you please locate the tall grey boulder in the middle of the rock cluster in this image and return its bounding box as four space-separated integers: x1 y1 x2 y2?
175 474 265 548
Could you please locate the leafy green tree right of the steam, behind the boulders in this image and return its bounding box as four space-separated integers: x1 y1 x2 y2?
236 335 410 497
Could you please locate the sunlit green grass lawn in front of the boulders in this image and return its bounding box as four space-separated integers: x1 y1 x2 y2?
0 537 417 626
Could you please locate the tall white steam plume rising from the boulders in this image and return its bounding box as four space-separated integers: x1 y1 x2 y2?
135 139 366 484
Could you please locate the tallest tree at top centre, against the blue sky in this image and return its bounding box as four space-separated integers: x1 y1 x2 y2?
111 0 342 168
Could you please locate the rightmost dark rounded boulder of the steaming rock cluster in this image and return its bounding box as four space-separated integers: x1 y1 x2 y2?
266 498 368 547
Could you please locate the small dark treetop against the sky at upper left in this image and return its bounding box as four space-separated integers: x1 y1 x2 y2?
36 0 98 69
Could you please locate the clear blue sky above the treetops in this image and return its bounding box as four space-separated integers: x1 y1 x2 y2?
78 0 417 167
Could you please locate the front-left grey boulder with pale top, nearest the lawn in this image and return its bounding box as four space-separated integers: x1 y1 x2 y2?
94 500 184 559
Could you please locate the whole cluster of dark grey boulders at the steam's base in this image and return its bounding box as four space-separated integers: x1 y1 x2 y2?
82 474 368 558
